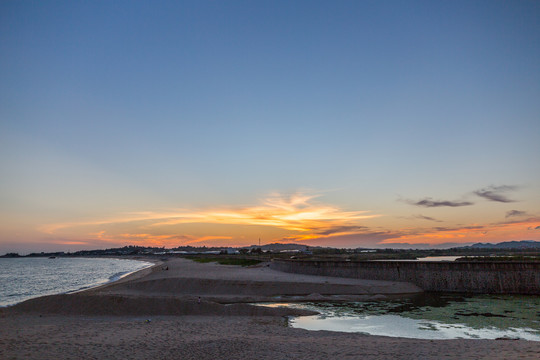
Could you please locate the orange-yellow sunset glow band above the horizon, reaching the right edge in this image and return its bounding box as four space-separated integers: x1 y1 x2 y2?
33 193 540 247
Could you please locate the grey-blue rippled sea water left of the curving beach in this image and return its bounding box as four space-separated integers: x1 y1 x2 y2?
0 257 152 306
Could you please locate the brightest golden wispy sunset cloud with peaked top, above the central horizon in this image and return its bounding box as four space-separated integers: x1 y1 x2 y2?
41 193 380 243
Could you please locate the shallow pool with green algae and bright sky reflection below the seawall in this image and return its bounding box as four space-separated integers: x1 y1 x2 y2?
262 294 540 341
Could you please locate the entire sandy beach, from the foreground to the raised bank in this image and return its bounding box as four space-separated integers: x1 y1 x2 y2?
0 259 540 359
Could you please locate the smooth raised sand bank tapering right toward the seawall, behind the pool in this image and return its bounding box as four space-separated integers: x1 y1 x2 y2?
93 259 422 303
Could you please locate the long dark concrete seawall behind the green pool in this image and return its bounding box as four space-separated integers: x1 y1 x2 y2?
270 260 540 295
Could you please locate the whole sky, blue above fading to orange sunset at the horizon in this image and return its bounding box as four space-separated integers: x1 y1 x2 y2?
0 0 540 253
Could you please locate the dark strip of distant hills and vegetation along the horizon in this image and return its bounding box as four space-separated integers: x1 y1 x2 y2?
0 241 540 265
